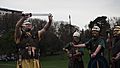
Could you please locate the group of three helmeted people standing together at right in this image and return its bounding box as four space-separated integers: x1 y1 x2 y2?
63 25 120 68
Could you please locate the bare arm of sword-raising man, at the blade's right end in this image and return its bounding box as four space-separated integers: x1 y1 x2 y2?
38 15 52 39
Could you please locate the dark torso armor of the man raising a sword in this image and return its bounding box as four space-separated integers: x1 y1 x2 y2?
17 30 39 59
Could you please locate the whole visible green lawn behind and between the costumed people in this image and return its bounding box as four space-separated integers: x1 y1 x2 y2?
0 50 88 68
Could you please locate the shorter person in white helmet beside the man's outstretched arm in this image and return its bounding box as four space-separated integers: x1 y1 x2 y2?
63 32 84 68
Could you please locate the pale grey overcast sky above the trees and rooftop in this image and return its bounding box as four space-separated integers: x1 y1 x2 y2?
0 0 120 28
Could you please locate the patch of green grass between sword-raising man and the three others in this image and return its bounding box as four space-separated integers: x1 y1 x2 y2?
41 55 68 68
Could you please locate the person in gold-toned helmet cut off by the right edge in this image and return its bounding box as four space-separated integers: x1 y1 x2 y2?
112 25 120 68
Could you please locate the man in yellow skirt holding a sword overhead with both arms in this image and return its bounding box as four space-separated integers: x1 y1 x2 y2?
15 14 52 68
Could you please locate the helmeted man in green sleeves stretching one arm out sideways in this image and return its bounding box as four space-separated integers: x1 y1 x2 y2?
74 25 108 68
